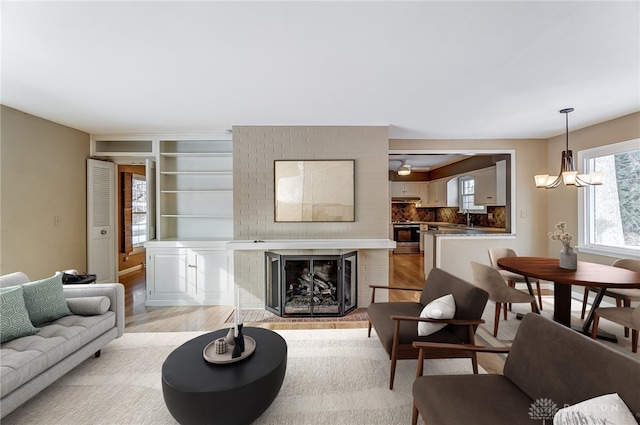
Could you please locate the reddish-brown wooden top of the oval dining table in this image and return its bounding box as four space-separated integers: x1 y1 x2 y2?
498 257 640 288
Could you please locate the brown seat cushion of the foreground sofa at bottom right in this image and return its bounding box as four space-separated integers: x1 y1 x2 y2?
413 375 532 425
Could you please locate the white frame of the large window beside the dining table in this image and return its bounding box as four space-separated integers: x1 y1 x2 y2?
578 139 640 258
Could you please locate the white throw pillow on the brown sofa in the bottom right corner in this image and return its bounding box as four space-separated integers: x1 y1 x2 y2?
553 393 637 425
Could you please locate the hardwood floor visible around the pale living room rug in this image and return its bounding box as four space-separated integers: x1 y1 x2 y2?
120 254 504 373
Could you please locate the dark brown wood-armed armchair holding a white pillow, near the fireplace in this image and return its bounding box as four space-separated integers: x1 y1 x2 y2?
367 268 489 389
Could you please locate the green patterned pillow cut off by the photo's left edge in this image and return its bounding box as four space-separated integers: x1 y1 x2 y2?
0 286 40 342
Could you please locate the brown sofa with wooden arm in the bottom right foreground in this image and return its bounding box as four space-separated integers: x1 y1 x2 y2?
412 313 640 425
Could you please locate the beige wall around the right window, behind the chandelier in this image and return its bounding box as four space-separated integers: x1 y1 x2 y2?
537 110 640 264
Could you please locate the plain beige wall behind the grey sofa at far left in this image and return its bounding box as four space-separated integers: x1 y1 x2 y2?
0 106 89 279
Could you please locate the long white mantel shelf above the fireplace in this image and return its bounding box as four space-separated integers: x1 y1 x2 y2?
227 239 396 251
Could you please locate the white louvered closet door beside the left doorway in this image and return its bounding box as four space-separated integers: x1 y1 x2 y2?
87 159 117 282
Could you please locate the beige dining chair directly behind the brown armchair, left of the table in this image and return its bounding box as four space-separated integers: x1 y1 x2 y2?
471 261 536 337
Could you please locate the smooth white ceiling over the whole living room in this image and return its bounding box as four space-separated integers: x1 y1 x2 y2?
1 1 640 139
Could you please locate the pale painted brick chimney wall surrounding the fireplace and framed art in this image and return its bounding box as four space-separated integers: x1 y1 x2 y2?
233 126 391 309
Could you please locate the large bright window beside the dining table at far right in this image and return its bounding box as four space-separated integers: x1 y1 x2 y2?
578 139 640 257
